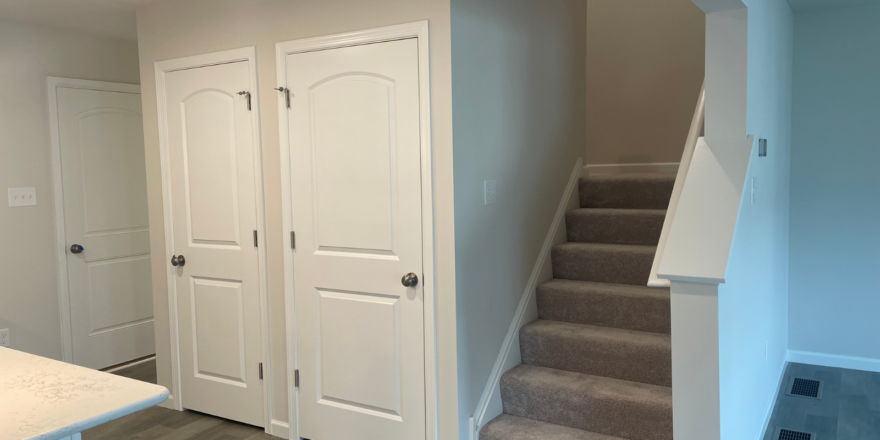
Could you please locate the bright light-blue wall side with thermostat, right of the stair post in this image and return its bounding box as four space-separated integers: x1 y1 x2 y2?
719 0 793 440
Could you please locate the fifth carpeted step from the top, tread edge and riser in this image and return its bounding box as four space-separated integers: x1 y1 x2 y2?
519 319 672 387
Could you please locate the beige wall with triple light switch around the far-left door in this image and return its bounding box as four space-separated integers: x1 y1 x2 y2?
0 20 139 359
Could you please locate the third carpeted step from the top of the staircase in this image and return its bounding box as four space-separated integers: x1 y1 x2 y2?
551 242 657 286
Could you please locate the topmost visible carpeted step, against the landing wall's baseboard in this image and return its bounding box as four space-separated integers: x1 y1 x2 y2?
578 173 675 209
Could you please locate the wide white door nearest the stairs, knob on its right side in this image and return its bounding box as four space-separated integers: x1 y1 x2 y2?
286 39 426 440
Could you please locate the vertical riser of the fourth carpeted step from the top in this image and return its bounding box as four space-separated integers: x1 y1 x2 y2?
537 285 671 334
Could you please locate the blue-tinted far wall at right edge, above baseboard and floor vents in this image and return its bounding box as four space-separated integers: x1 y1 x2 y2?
789 2 880 359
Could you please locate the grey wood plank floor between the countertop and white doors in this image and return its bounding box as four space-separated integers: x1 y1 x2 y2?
82 360 278 440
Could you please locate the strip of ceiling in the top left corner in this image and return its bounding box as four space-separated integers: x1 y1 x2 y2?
0 0 166 40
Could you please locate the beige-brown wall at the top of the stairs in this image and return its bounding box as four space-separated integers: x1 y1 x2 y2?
586 0 706 164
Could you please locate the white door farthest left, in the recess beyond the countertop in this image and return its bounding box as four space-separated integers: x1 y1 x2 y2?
56 87 156 368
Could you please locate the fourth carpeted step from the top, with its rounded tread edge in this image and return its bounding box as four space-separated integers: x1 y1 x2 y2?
536 279 671 334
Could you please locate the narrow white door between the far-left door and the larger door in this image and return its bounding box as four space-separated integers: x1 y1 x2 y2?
165 61 264 426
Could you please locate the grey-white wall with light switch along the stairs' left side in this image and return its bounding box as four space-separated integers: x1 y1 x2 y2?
452 0 588 439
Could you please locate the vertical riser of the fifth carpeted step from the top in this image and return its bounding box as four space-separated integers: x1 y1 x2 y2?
519 326 672 387
